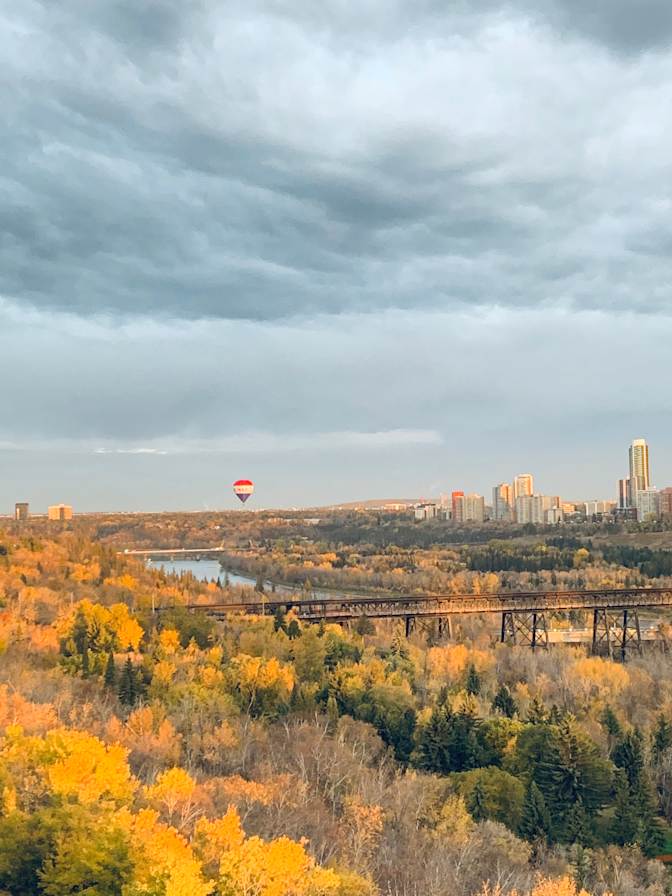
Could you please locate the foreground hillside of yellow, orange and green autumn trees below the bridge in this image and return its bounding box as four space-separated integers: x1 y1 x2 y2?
0 528 672 896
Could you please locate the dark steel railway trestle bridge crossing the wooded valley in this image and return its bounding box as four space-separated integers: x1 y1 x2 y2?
181 587 672 659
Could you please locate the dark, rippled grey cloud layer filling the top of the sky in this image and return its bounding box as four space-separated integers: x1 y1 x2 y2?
5 0 672 320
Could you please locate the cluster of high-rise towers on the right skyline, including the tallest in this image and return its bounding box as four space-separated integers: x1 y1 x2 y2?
414 439 672 525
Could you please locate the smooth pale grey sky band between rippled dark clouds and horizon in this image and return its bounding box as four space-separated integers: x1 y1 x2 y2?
0 303 672 510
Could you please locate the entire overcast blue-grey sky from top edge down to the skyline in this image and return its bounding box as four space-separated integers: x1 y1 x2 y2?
0 0 672 512
